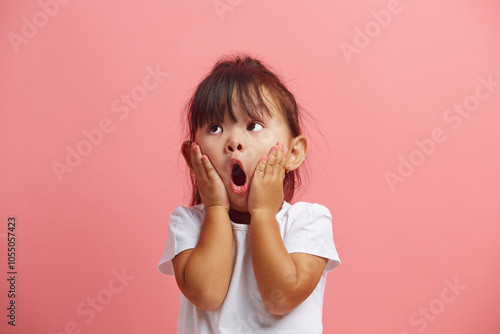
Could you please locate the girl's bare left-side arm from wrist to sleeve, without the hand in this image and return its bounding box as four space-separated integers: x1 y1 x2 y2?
172 206 233 311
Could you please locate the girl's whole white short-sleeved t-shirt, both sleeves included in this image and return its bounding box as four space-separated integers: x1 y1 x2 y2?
158 201 340 334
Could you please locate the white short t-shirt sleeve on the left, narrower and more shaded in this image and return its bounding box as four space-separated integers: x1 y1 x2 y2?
158 205 203 275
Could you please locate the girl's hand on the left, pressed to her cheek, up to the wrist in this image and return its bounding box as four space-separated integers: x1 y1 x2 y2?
191 142 230 212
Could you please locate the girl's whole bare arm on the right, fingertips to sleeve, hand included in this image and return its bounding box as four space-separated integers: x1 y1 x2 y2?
248 143 328 315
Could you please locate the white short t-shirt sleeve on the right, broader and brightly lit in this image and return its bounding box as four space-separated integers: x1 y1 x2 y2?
283 202 340 271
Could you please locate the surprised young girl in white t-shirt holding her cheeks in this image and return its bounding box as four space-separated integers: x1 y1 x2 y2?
158 57 340 334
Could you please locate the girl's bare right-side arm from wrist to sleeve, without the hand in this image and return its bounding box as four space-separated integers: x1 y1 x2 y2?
250 211 328 315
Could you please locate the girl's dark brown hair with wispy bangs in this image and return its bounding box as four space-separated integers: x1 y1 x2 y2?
187 56 308 206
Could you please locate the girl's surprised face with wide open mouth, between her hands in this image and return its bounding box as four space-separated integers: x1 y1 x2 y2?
195 102 293 212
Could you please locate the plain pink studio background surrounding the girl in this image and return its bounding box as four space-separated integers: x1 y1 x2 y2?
0 0 500 334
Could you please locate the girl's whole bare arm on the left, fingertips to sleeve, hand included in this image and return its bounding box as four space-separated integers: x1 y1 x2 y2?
172 141 233 311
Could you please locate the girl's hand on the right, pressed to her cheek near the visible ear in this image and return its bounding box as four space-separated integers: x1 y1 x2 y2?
248 142 288 215
